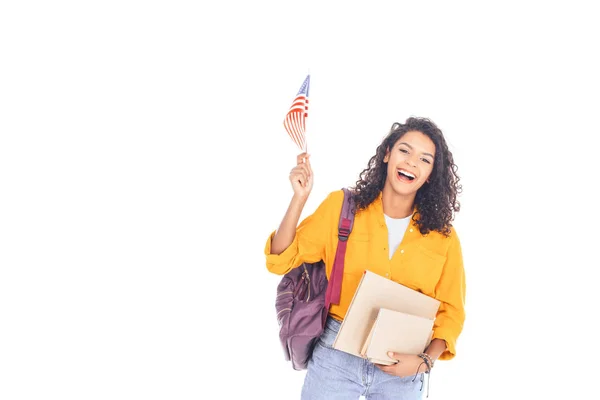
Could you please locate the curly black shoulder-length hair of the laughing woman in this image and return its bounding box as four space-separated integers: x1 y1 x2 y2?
353 117 462 236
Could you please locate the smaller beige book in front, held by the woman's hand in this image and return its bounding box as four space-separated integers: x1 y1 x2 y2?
360 308 434 365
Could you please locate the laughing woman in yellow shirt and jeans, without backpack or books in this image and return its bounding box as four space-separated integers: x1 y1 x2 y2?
265 118 465 400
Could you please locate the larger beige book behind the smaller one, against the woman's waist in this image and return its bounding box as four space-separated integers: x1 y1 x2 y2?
333 271 440 357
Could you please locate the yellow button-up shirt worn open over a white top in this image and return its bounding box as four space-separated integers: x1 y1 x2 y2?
265 190 466 360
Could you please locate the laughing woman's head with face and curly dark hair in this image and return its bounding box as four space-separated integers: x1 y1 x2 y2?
356 118 462 234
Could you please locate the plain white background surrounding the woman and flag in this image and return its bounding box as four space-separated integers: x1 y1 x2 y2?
0 0 600 400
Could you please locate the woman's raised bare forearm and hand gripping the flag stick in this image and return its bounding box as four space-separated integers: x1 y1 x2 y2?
271 153 313 254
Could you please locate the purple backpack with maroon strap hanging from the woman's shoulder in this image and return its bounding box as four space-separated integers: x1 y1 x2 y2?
275 188 354 371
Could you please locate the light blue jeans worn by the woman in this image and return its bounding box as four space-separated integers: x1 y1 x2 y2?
301 317 424 400
